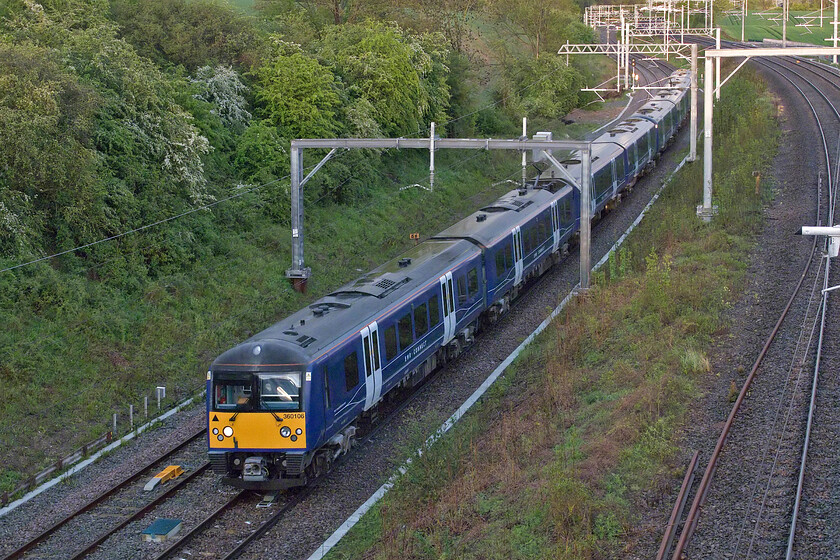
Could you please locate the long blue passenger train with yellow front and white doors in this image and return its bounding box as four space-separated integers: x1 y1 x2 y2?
206 70 690 491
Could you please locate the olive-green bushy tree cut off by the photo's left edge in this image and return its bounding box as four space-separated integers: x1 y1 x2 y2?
0 42 105 255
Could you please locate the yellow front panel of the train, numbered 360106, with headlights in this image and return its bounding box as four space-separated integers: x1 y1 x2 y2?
208 411 306 451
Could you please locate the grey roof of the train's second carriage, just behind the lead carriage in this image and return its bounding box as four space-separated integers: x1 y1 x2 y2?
433 186 571 247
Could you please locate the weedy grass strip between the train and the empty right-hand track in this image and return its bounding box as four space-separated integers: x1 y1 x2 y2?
320 71 778 560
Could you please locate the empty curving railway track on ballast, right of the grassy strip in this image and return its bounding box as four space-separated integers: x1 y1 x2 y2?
658 38 840 560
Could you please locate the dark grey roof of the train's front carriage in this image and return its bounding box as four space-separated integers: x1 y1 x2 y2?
213 239 480 370
